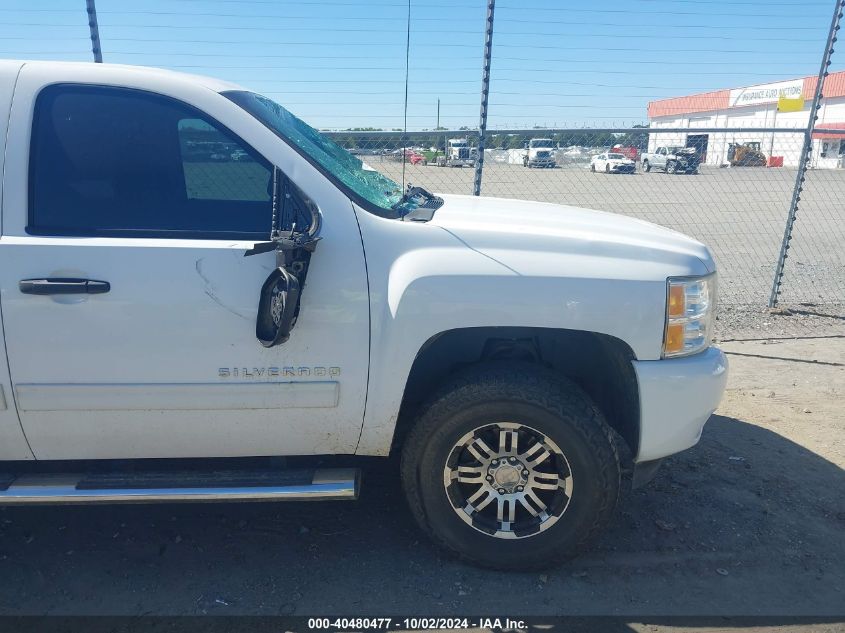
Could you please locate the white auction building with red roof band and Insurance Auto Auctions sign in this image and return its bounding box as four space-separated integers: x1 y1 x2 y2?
648 71 845 169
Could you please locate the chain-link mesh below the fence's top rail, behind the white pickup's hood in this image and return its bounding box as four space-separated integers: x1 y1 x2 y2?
330 127 845 338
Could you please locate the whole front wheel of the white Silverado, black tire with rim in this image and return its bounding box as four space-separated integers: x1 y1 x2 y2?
402 363 619 569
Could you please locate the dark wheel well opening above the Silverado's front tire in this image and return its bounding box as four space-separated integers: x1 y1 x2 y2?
391 327 640 454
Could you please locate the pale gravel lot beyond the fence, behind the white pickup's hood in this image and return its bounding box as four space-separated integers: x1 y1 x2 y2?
376 162 845 315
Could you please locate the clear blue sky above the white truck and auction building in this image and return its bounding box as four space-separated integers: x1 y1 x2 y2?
0 0 845 130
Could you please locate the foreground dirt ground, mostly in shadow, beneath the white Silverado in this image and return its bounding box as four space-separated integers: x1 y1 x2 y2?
0 338 845 616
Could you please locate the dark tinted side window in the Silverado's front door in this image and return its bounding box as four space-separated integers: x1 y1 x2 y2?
27 85 272 239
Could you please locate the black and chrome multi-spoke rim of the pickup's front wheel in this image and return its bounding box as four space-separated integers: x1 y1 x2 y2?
443 422 572 539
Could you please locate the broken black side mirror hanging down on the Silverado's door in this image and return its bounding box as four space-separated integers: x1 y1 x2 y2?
244 168 321 347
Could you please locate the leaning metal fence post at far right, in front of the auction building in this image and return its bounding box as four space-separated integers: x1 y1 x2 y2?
769 0 845 308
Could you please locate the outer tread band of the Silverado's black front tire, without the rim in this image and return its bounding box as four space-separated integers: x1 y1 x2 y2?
401 362 621 570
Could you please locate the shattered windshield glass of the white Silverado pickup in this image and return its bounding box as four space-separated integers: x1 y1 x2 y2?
223 90 418 215
